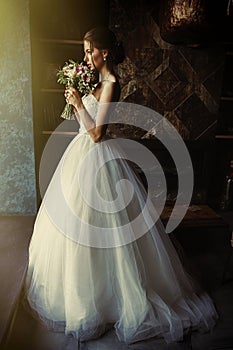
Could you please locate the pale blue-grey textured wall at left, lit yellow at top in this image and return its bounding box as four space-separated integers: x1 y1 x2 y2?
0 0 36 214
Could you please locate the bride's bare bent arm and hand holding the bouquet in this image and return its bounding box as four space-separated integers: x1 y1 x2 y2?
66 81 115 142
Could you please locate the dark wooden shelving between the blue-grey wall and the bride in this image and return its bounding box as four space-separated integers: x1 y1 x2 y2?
30 0 109 205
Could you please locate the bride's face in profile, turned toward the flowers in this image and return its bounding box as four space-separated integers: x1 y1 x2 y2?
84 40 104 71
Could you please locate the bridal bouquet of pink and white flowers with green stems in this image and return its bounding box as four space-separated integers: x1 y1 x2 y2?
57 60 95 120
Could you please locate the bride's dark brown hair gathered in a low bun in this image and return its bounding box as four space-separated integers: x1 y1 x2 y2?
83 27 125 66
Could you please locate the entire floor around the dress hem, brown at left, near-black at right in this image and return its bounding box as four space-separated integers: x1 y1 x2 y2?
0 212 233 350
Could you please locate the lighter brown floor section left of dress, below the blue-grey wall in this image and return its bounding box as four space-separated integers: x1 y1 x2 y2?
0 216 35 343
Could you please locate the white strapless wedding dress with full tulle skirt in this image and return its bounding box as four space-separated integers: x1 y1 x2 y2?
26 94 217 343
